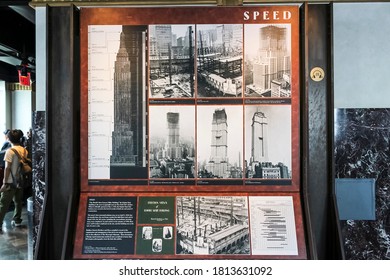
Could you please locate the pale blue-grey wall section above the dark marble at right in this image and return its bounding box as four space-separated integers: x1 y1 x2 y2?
333 3 390 108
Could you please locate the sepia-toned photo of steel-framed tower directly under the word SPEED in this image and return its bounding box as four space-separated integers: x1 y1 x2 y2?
244 24 291 98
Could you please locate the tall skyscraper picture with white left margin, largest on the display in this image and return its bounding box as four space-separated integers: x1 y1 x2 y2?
88 25 147 179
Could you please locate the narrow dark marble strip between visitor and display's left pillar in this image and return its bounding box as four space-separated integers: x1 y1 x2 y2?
32 111 46 252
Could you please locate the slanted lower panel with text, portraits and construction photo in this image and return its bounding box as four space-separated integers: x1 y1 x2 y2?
75 193 305 259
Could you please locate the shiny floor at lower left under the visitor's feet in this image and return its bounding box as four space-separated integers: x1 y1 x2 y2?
0 207 31 260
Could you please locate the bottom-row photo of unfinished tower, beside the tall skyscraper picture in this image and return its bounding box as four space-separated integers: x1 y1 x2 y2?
149 105 195 179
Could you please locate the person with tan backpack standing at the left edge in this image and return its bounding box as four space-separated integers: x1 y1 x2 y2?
0 129 27 233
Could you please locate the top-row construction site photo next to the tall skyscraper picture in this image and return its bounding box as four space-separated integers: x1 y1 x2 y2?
149 24 195 98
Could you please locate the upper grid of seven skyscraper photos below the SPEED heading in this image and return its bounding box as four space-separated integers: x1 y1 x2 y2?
88 24 293 185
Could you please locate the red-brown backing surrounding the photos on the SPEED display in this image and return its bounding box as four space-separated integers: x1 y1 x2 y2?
74 6 307 259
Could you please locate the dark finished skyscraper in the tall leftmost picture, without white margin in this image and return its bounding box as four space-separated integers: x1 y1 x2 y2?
110 26 147 179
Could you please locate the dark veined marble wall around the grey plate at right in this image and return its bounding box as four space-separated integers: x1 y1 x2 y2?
335 109 390 260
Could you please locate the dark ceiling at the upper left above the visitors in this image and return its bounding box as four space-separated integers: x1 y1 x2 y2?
0 0 35 82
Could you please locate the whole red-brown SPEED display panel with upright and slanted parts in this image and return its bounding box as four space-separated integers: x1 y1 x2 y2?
73 6 307 259
